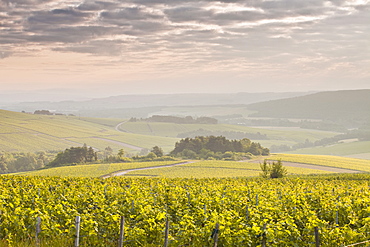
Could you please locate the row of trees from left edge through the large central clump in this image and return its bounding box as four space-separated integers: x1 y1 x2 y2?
0 136 270 173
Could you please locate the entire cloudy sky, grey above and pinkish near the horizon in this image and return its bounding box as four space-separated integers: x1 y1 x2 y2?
0 0 370 95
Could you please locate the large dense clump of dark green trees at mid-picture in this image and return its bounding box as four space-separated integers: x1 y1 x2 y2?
171 136 269 159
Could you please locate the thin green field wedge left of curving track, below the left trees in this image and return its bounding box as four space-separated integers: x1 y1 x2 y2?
14 161 179 177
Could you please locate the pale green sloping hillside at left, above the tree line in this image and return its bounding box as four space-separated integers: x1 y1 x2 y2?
0 110 178 152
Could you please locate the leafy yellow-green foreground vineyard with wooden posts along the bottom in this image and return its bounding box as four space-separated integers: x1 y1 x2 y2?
0 174 370 246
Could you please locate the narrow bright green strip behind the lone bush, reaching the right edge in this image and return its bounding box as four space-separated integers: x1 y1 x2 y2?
268 154 370 172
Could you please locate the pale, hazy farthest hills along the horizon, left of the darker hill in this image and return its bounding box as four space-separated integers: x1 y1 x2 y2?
1 92 312 118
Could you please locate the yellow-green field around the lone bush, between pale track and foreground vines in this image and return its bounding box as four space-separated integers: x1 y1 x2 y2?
125 161 330 178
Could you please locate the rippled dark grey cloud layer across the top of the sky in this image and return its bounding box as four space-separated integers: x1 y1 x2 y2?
0 0 370 62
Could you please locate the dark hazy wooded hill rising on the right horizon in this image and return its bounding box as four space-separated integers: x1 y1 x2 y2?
247 89 370 127
